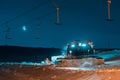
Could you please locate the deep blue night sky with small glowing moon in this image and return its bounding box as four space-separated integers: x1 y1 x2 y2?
0 0 120 48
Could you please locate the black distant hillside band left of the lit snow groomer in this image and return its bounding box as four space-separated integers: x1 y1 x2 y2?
0 46 61 62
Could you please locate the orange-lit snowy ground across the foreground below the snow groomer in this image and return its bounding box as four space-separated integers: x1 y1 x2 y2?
0 57 120 80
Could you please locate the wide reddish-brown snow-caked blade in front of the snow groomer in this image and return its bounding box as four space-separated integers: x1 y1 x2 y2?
57 58 104 67
